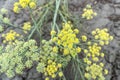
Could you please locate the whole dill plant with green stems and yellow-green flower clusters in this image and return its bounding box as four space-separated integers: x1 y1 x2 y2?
0 0 113 80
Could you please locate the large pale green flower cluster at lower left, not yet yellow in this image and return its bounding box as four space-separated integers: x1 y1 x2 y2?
0 40 39 77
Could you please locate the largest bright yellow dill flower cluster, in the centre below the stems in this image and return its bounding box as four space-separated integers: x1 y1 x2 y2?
51 22 81 55
